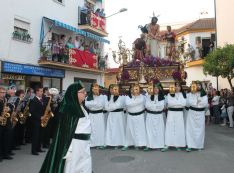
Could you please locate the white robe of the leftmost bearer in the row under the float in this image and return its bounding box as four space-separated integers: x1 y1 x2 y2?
85 95 106 147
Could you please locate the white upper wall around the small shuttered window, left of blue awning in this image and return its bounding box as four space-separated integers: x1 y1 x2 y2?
0 0 83 64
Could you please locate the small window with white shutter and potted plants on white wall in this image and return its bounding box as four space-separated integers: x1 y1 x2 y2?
13 18 32 43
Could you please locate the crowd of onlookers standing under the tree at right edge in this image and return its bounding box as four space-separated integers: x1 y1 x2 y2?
206 88 234 128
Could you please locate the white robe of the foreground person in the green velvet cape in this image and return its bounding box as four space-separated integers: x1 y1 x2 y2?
64 107 92 173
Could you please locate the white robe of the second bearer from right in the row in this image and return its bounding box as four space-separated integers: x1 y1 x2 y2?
165 93 186 147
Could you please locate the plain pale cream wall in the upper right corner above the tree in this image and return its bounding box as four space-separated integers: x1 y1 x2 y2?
216 0 234 46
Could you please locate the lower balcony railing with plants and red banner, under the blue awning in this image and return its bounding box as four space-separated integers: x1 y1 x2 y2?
39 43 106 70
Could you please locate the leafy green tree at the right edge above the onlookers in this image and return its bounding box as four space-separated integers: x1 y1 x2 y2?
203 44 234 88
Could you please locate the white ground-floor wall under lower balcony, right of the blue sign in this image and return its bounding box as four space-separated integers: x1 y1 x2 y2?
63 70 104 90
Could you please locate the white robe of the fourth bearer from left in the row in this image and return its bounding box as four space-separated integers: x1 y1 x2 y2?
145 95 165 148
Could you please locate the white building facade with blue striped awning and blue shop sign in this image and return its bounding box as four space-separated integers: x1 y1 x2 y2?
0 0 108 90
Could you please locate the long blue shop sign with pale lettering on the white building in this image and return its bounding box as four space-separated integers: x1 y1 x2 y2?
2 62 65 78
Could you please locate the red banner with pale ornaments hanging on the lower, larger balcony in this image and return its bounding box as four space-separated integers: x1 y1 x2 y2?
69 49 97 69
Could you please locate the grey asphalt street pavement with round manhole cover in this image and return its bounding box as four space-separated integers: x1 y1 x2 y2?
0 125 234 173
